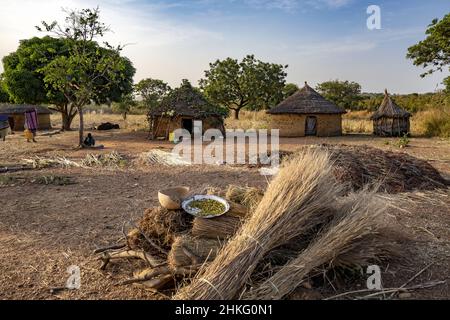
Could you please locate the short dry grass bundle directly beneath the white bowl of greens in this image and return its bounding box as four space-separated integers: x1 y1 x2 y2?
191 214 241 239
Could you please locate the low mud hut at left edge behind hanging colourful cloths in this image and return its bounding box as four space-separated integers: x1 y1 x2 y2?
0 103 52 131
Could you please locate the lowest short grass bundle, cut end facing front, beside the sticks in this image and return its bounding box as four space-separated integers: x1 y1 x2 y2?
167 235 222 269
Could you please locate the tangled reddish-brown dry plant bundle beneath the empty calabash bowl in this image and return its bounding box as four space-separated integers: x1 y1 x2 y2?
128 207 192 250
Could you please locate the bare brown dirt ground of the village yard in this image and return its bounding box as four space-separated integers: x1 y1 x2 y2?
0 130 450 299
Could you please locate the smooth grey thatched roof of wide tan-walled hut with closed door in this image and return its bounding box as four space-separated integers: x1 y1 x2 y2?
268 82 346 114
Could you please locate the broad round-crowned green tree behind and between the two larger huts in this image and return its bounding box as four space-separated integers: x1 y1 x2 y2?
199 55 287 119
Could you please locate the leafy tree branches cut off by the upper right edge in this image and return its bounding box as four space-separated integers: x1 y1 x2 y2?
406 13 450 92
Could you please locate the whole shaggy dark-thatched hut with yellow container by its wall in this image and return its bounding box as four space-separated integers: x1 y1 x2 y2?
148 80 227 139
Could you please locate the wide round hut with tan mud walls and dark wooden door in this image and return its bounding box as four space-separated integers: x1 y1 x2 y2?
268 82 346 137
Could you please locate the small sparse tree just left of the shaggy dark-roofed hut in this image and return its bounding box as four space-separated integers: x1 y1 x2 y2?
134 78 171 110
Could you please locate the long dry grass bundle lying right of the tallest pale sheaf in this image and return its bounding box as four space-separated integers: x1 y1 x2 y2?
244 192 398 300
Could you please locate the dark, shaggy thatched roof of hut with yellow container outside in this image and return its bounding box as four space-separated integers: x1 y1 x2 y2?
149 80 227 118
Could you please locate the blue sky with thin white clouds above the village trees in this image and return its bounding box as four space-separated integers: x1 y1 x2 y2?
0 0 450 93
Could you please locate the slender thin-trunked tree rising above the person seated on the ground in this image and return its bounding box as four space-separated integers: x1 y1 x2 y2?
37 8 135 147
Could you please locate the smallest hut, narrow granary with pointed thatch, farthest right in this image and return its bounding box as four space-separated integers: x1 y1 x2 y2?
371 90 411 137
